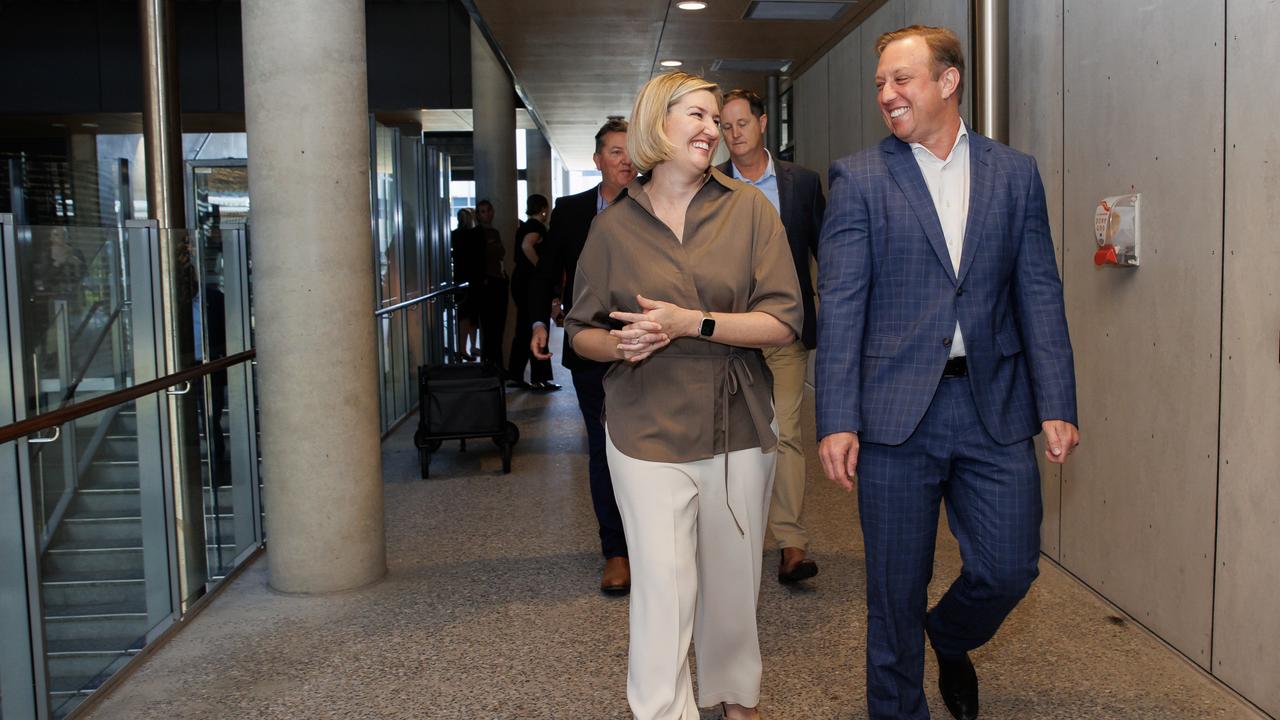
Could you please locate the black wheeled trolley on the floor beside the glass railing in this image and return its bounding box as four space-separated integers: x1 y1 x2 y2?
413 363 520 479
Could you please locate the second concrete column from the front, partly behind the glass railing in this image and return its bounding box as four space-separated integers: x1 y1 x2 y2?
471 23 524 364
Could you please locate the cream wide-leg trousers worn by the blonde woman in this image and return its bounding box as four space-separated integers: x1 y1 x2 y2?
605 428 777 720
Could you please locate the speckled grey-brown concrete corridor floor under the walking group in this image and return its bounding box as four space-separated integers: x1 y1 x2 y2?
82 348 1261 720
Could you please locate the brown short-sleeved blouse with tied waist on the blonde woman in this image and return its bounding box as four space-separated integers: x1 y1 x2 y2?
564 168 804 462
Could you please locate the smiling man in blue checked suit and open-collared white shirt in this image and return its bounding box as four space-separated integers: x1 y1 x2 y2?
817 26 1079 720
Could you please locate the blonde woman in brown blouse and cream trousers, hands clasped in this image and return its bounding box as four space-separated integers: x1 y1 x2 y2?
566 73 804 720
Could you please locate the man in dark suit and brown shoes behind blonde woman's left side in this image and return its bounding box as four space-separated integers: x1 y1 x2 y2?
529 118 636 594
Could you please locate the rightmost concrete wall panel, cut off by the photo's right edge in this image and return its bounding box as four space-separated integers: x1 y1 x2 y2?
1213 0 1280 716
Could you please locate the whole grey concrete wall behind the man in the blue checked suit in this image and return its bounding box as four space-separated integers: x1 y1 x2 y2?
794 0 1280 716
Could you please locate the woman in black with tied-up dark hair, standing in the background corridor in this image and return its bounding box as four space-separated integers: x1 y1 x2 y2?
507 195 561 392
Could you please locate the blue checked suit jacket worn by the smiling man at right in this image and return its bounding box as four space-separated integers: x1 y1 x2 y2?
817 129 1076 445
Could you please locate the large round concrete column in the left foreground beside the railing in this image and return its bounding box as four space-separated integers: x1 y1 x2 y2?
241 0 387 593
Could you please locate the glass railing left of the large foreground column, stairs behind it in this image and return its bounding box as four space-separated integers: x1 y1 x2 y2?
0 215 262 717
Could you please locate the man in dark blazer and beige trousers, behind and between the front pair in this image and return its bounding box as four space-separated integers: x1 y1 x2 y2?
719 90 827 583
